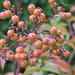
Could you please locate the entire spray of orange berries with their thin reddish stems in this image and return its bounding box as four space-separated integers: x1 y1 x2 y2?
0 0 71 68
